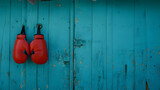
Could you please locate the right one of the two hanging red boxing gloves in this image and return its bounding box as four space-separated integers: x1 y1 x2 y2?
30 26 48 64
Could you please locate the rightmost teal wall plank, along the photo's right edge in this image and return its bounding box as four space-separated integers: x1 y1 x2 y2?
145 0 160 90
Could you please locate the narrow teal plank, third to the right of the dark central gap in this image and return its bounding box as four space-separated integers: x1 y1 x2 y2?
106 0 114 90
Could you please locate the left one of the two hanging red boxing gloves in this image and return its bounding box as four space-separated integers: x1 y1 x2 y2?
13 26 29 64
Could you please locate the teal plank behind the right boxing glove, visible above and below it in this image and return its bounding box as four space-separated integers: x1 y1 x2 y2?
37 2 49 90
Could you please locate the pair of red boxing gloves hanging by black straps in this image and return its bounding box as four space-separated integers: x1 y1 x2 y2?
13 25 48 64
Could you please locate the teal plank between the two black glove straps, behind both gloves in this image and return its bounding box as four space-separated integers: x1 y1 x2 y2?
26 2 38 90
